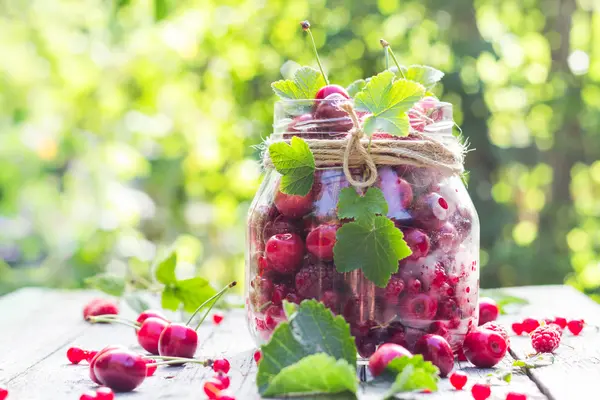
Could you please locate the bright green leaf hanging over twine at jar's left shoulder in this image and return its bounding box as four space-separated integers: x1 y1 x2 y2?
269 136 315 196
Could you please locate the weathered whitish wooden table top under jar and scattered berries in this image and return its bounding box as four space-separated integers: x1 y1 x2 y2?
0 286 600 400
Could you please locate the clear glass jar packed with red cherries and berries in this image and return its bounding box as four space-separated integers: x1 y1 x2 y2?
246 98 479 358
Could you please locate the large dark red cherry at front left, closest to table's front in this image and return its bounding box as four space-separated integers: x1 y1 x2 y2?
94 349 146 392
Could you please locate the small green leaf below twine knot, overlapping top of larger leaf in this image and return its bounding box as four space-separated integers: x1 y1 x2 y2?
338 187 388 219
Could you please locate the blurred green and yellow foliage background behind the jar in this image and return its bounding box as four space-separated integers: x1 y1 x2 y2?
0 0 600 300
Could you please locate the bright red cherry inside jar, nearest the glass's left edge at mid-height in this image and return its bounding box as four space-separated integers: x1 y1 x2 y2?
265 233 304 274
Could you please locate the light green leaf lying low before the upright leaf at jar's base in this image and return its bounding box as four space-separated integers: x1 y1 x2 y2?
263 353 358 397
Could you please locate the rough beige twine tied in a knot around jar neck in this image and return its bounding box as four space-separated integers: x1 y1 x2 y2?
263 102 467 188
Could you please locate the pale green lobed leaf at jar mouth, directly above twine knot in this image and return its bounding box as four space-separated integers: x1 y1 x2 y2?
354 71 425 136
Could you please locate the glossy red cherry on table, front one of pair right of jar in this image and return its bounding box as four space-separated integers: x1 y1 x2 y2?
463 329 508 368
